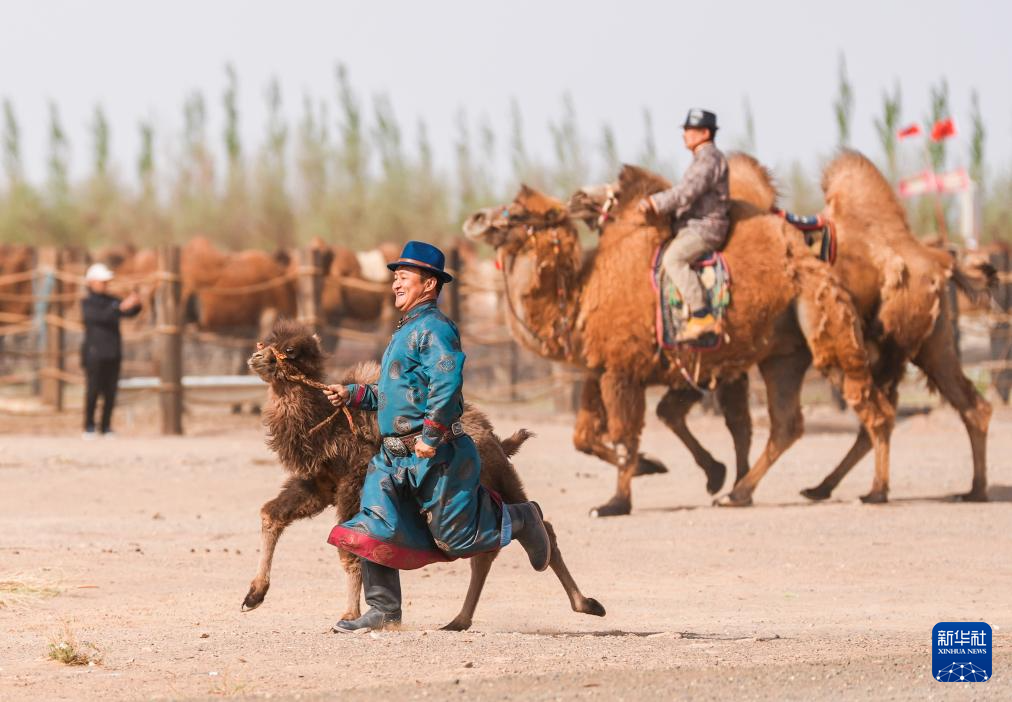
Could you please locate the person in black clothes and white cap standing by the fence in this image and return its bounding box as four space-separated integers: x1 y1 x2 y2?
81 263 141 439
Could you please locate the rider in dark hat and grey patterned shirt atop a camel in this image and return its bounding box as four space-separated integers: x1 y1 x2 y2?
640 108 729 342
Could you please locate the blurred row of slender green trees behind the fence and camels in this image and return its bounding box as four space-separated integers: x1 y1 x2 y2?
0 58 1012 248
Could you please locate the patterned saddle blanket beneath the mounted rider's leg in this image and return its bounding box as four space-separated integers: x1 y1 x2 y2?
650 239 731 351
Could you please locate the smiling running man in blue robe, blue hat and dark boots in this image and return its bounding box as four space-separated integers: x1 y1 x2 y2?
327 242 552 632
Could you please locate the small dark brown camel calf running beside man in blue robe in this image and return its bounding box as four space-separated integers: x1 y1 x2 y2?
243 320 604 630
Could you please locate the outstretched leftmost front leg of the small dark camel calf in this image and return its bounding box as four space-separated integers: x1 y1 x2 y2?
242 478 333 612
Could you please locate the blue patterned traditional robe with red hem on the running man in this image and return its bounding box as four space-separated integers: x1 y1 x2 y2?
328 301 512 569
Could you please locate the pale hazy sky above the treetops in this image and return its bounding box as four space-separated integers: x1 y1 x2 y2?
0 0 1012 187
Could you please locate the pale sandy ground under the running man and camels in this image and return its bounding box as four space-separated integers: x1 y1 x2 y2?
0 400 1012 701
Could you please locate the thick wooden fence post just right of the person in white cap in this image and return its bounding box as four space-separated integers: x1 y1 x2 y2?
155 245 183 435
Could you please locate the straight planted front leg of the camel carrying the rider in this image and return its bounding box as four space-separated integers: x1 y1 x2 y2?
590 370 647 517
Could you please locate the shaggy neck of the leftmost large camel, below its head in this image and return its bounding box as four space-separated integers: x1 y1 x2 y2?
502 237 583 363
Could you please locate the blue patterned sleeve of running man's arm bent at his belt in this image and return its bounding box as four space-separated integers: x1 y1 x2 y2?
418 319 467 446
